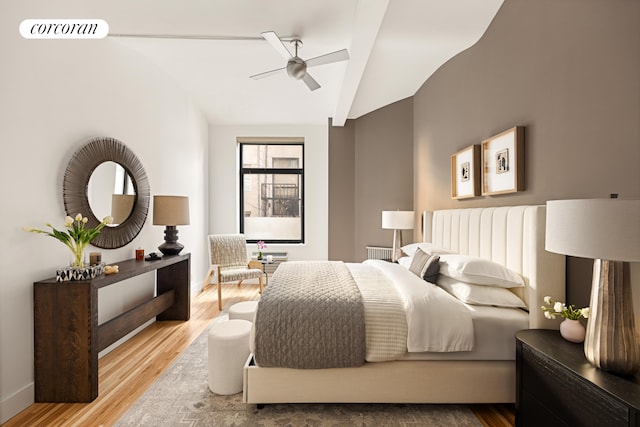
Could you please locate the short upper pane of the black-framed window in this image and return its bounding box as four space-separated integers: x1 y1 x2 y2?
242 144 302 169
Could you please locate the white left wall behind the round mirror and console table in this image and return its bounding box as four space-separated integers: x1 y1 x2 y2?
0 2 209 422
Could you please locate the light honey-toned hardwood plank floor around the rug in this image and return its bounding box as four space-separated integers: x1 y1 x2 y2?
3 284 515 427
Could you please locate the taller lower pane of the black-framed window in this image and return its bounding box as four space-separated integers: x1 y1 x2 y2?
244 174 302 240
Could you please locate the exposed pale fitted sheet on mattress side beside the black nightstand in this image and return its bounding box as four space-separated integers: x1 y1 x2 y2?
401 304 529 360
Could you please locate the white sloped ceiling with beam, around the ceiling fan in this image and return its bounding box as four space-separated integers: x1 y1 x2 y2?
61 0 503 125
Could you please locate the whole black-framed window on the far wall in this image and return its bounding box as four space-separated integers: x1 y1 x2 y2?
239 138 304 243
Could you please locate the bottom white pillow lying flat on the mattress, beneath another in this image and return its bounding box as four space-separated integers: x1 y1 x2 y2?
437 275 527 308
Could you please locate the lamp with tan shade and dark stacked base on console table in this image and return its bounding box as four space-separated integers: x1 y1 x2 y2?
153 196 189 255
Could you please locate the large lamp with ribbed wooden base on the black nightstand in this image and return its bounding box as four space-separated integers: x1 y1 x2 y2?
545 199 640 375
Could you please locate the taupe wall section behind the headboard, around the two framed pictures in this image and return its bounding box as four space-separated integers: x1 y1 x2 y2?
413 0 640 305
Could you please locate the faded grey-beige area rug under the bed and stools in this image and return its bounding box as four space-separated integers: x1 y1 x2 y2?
116 313 482 427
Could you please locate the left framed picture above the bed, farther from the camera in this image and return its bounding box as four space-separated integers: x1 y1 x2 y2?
451 144 480 199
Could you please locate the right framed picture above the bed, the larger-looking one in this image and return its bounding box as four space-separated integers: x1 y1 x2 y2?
482 126 524 196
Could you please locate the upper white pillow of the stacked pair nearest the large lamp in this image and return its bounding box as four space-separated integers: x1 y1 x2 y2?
440 254 524 288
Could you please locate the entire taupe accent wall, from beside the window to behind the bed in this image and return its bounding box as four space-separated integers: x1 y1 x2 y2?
329 0 640 311
